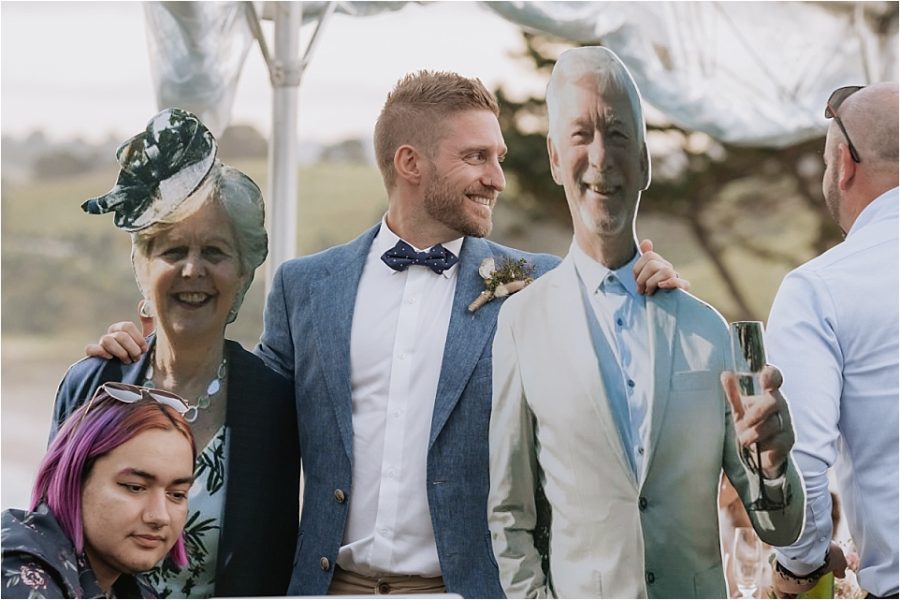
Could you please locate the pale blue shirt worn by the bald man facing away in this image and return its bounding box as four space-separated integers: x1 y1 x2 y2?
767 188 900 596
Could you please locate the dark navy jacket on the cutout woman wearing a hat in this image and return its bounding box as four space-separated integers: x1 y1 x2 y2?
50 336 300 596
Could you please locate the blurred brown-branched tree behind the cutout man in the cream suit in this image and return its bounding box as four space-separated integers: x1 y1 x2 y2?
496 33 840 319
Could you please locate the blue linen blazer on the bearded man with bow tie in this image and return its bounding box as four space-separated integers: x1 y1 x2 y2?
256 224 559 598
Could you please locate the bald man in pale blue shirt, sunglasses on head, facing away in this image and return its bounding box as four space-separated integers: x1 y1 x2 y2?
768 83 900 598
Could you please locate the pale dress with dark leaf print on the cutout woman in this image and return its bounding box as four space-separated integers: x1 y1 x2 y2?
147 426 228 598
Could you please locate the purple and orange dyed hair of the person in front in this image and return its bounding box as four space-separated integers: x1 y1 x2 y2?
30 399 197 566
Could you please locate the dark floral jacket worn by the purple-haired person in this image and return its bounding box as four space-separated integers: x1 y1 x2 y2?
0 504 156 598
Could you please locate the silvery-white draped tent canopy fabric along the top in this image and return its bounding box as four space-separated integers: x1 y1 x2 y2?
145 2 898 147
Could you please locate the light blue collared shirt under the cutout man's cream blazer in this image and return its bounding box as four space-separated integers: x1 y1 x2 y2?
569 240 653 481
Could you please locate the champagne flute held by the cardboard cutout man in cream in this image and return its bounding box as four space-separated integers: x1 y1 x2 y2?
730 321 779 511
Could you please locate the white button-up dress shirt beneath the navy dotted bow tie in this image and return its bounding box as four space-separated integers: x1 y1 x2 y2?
337 219 463 577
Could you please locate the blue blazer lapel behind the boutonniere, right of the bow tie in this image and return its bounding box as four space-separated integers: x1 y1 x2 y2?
428 237 503 448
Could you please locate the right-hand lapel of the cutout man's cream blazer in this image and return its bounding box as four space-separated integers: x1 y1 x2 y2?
641 291 681 485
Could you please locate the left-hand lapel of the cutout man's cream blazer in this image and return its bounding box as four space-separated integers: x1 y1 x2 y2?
545 255 637 484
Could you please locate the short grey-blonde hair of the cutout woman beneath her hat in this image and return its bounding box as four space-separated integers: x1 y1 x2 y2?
131 160 269 323
